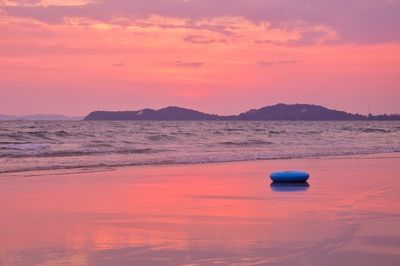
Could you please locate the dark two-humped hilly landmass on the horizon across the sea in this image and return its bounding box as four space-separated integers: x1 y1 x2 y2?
85 104 400 121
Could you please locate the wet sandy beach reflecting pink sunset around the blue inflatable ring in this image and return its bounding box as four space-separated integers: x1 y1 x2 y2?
0 154 400 265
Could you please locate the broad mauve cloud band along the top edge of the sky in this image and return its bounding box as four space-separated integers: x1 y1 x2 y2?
0 0 400 43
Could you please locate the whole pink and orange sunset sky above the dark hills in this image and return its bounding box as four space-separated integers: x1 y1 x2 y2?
0 0 400 116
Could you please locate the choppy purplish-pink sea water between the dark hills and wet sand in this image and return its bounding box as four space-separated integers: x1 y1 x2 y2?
0 121 400 173
